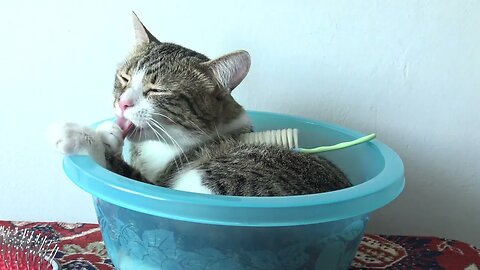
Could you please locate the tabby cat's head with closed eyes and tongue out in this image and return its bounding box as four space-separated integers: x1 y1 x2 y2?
114 14 251 145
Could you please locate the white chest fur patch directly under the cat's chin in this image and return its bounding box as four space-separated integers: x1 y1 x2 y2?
133 141 179 183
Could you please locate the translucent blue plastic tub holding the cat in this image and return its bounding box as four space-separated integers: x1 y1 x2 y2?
64 112 404 270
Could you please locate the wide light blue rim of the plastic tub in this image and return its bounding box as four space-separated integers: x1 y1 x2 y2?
63 111 405 226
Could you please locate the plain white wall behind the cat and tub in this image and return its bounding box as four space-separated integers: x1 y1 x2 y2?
0 0 480 245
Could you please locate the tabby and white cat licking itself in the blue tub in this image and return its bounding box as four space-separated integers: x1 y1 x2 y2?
50 13 351 196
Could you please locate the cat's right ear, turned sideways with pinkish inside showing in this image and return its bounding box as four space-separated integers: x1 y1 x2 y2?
203 51 250 92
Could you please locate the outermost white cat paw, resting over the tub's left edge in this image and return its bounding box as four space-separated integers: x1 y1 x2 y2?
48 123 95 155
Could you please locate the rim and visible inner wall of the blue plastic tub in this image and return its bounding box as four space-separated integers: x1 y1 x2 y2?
64 109 404 226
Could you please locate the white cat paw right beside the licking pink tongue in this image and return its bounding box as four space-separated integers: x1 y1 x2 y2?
95 121 123 154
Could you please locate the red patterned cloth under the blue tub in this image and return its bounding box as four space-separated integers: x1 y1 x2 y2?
0 221 480 270
